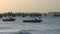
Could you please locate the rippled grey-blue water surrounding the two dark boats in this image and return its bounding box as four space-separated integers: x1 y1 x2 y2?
0 16 60 34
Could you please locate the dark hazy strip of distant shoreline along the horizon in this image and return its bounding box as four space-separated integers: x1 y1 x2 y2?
0 12 60 17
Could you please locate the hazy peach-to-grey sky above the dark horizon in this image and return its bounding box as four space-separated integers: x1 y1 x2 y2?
0 0 60 13
